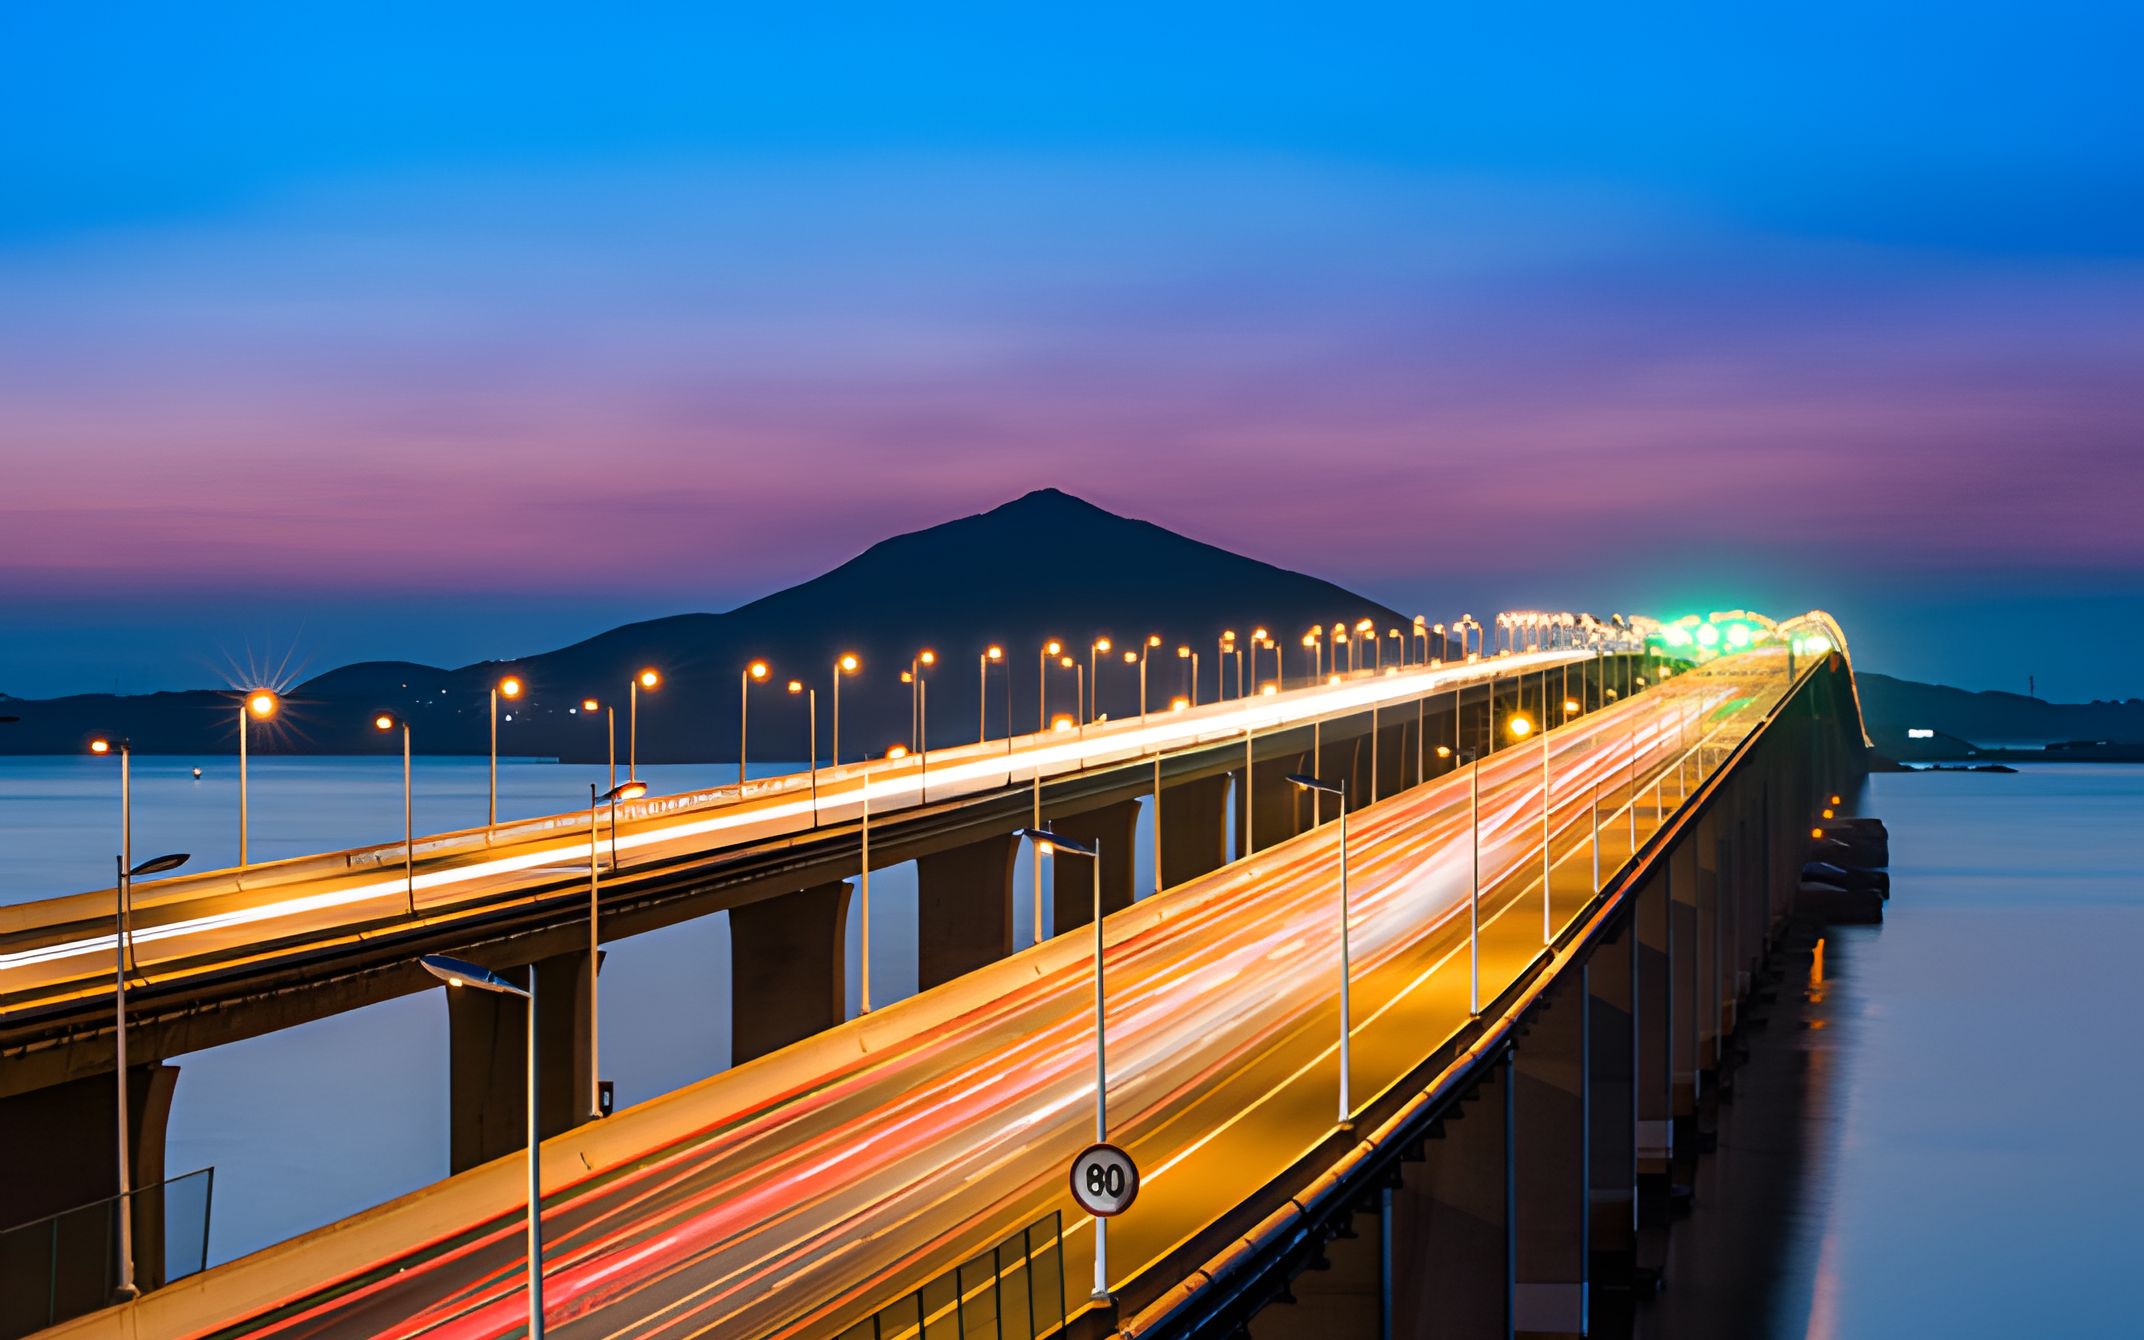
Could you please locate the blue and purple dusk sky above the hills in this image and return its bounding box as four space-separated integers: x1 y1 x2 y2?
0 2 2144 699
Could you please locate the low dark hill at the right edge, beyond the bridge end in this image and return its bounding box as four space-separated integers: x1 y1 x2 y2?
1855 671 2144 759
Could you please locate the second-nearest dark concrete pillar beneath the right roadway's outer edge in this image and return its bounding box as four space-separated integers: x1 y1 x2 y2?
1389 1057 1516 1340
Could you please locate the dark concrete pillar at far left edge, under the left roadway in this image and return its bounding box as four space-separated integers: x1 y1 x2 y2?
0 1063 177 1336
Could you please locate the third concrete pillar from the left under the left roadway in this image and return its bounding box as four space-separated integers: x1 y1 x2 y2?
729 879 849 1066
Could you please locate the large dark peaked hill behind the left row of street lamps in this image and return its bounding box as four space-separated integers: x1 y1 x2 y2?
0 489 1440 761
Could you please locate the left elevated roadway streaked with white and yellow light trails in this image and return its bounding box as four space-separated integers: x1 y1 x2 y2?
0 650 1591 1012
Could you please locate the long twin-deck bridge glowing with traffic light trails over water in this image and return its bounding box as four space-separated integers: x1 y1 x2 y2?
0 617 1861 1336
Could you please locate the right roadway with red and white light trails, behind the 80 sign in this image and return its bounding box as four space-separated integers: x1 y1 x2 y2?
92 654 1784 1336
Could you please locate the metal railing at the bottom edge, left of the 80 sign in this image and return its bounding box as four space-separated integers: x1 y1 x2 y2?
836 1209 1066 1340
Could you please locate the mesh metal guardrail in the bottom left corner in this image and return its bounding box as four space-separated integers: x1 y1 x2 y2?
0 1168 217 1340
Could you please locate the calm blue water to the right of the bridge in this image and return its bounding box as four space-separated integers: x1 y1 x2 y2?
1640 765 2144 1338
